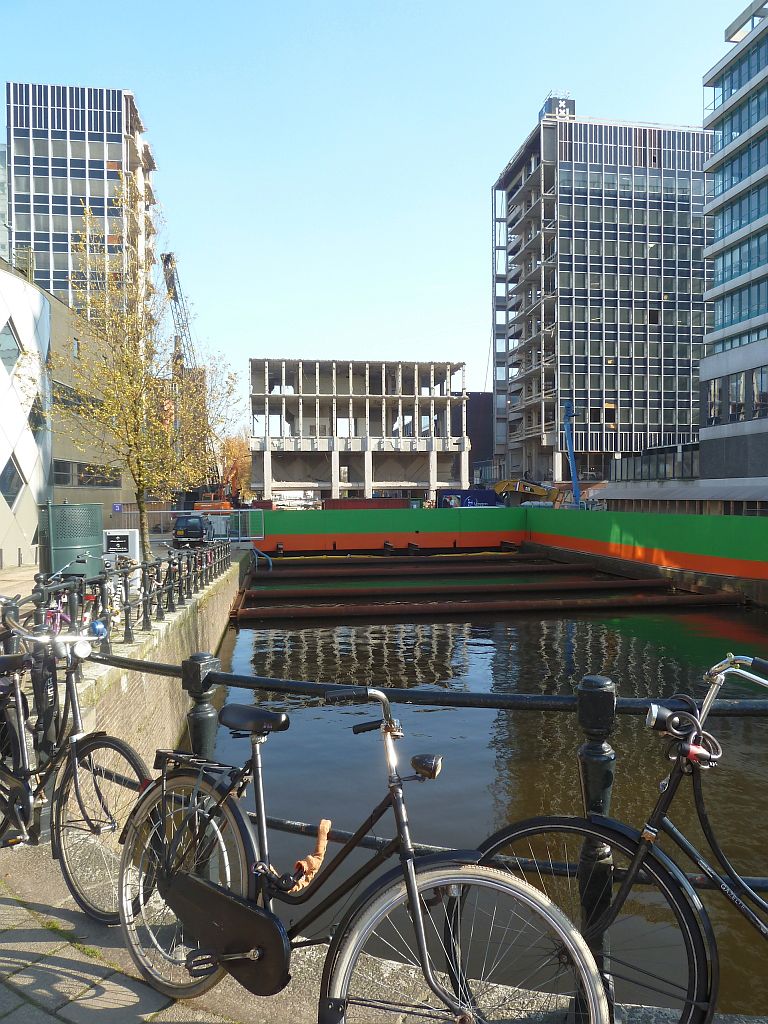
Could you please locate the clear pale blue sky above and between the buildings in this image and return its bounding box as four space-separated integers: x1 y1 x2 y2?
0 0 733 420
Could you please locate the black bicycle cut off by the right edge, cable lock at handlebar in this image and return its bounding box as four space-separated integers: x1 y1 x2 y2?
480 654 768 1024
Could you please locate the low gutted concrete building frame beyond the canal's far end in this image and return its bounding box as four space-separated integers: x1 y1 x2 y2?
251 358 470 501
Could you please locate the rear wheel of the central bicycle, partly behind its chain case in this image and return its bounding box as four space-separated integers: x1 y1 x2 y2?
119 771 257 999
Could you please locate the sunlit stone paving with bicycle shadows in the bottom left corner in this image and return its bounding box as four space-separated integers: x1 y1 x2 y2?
0 847 322 1024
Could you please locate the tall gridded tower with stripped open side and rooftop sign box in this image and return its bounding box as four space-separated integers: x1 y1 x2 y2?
493 96 711 480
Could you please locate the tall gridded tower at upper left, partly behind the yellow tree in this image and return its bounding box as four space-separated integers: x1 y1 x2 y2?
6 82 155 304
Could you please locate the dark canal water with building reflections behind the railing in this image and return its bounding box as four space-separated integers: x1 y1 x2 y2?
217 609 768 1014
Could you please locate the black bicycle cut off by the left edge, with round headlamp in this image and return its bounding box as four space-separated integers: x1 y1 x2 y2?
0 597 150 924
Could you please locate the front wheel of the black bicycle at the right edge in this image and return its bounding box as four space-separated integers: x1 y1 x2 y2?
479 817 710 1024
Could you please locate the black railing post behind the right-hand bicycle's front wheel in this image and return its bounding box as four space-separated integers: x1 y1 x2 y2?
577 676 616 1020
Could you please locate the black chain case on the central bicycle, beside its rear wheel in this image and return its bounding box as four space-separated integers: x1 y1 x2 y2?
162 871 291 995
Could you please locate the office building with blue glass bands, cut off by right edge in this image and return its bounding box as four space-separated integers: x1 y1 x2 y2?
700 2 768 483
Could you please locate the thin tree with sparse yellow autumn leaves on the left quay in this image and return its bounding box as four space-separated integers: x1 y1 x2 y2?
52 192 236 559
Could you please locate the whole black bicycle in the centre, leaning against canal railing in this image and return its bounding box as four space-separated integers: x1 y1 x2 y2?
120 686 607 1024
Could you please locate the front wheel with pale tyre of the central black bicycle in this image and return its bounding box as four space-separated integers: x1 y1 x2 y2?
319 864 608 1024
